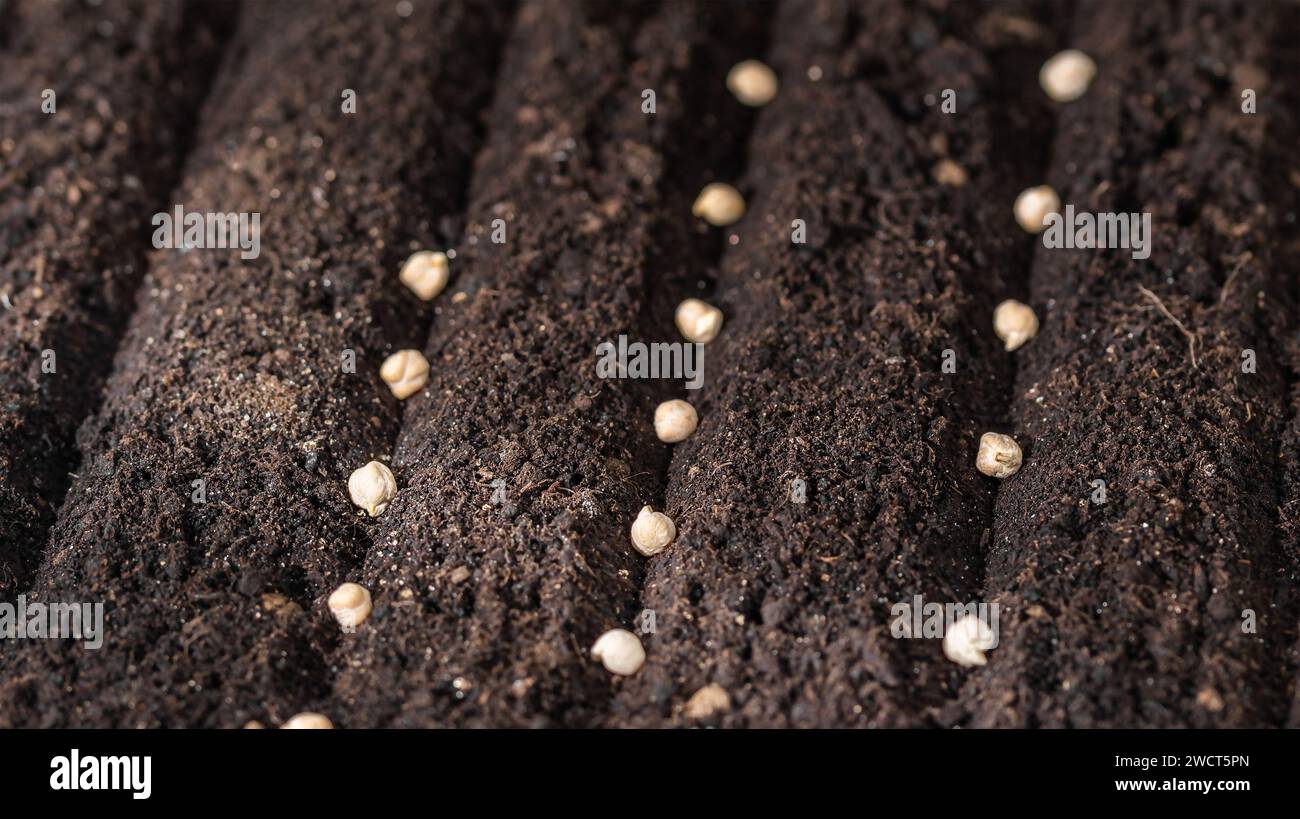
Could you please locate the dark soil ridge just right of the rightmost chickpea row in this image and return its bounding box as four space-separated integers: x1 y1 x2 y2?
962 3 1292 727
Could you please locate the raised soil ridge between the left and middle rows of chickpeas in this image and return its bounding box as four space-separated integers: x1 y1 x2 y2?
330 0 768 725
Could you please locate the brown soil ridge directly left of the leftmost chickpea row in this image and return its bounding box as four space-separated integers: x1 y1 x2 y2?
0 0 508 727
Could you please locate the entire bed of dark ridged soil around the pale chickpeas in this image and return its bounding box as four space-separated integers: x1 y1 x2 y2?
0 0 1300 727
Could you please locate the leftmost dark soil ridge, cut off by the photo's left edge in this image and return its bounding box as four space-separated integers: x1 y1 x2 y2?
0 0 238 602
